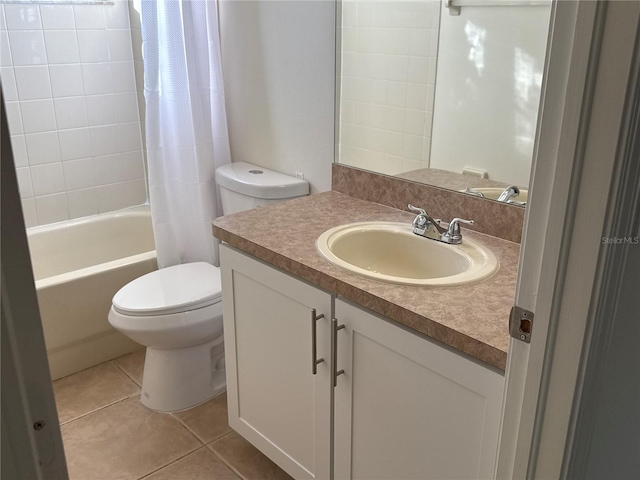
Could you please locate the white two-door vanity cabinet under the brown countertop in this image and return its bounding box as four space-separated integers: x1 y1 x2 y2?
220 245 504 480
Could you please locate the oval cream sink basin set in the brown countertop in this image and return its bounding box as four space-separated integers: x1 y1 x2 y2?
316 222 498 286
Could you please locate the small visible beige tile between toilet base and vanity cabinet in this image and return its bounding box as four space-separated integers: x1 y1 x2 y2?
174 392 231 443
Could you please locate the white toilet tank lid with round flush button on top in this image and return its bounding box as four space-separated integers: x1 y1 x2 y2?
216 162 309 199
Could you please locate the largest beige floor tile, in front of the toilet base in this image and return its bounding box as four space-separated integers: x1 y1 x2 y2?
62 398 202 480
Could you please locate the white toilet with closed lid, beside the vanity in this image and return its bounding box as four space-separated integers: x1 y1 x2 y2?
109 162 309 412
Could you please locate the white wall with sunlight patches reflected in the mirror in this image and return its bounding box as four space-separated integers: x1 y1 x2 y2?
431 4 551 186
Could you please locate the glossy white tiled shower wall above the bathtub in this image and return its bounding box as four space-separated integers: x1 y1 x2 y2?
0 0 147 227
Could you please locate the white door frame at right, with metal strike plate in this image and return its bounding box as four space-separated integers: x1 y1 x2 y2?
496 1 640 479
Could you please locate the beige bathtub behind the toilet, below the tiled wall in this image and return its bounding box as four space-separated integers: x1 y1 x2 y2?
27 205 157 380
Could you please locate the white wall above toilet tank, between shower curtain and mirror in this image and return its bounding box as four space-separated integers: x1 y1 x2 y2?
220 0 335 193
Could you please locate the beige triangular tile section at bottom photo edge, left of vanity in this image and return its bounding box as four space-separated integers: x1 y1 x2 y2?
145 447 240 480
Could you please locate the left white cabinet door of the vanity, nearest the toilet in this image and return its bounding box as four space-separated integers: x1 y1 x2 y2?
220 245 332 479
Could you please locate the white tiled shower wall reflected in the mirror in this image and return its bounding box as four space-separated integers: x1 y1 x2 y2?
339 0 440 175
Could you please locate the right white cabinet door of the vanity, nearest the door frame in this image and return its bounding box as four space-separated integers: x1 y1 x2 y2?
334 299 504 480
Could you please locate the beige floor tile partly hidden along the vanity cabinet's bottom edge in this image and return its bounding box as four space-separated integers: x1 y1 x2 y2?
209 432 291 480
